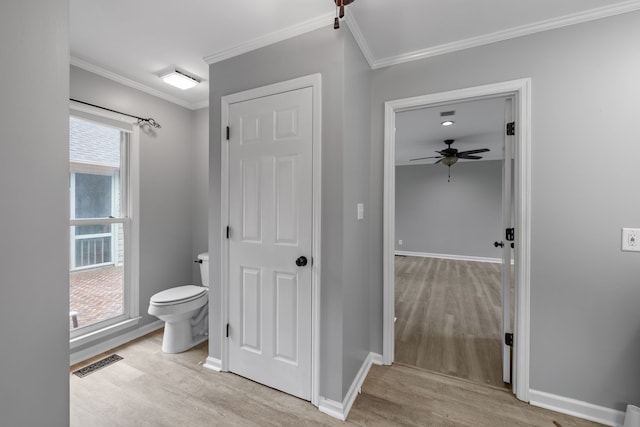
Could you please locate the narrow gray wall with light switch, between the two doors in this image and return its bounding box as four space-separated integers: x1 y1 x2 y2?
340 30 371 396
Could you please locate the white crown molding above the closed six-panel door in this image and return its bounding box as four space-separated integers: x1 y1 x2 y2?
203 13 334 65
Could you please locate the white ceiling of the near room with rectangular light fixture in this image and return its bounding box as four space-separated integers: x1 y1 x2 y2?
70 0 640 111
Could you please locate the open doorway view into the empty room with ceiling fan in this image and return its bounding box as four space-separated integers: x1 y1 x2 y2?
395 97 513 388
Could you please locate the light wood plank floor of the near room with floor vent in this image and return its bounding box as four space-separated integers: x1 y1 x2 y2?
69 331 598 427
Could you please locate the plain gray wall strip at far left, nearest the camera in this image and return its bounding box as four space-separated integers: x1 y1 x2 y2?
0 0 69 427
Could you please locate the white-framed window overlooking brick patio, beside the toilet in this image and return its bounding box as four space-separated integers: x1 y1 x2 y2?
69 108 139 348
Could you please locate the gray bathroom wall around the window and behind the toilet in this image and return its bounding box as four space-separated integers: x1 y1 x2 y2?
70 66 208 351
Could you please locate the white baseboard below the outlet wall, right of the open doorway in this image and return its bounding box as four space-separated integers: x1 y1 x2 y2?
529 390 625 427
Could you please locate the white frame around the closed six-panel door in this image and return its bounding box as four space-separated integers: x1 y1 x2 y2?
220 74 322 406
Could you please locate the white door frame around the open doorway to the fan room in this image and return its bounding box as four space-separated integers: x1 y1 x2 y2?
382 78 531 402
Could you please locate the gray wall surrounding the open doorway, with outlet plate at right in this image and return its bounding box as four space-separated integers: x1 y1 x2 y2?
371 12 640 410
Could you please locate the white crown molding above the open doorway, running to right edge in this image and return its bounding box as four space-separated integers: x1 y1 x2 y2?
370 0 640 70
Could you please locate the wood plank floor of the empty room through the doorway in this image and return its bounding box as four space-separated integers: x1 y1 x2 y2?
395 256 508 388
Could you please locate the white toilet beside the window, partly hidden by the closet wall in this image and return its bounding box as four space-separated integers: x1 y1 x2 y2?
148 252 209 353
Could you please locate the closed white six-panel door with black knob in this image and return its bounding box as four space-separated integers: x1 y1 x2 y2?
228 88 313 400
